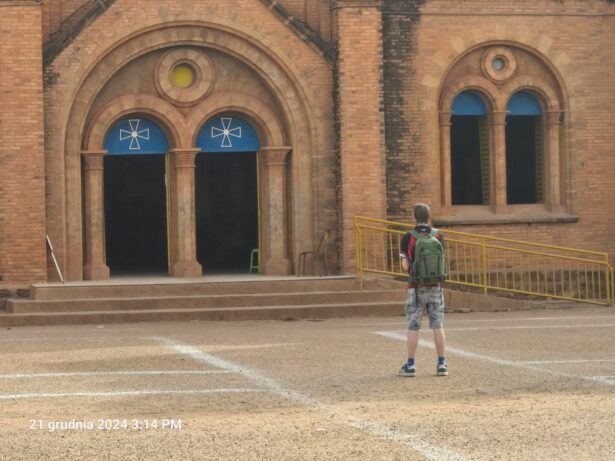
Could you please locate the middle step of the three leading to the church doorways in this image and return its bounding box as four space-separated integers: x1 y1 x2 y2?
6 290 405 314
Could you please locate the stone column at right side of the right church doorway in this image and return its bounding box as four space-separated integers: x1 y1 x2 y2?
258 147 292 275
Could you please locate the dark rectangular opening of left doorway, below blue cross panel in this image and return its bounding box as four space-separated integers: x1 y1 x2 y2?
105 154 168 275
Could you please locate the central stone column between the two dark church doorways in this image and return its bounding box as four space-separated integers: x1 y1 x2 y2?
167 148 203 277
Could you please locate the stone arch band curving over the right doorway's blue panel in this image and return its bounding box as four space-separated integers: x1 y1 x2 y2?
186 93 289 147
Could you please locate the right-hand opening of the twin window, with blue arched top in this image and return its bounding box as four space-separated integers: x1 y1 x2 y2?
506 91 544 204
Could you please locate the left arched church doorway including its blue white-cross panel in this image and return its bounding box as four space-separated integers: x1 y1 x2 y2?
104 116 169 276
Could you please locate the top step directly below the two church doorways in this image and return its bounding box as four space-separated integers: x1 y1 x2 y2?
29 276 358 300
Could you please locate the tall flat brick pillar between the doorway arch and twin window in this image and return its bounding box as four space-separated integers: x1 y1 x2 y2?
333 0 387 273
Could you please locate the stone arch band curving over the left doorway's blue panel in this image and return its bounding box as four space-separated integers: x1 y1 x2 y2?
83 94 187 151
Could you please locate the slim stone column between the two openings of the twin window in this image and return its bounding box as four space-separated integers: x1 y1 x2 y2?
491 111 507 213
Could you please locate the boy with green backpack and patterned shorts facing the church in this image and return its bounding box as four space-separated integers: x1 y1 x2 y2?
399 203 448 376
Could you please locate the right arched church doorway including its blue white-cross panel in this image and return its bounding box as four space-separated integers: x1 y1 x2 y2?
195 114 260 273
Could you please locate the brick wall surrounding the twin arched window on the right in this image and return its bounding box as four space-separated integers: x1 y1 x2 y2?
383 0 615 255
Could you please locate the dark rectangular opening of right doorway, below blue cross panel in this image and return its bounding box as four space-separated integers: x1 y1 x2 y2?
196 152 259 273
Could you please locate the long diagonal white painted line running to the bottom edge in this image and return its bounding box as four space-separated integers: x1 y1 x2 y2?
153 336 467 461
